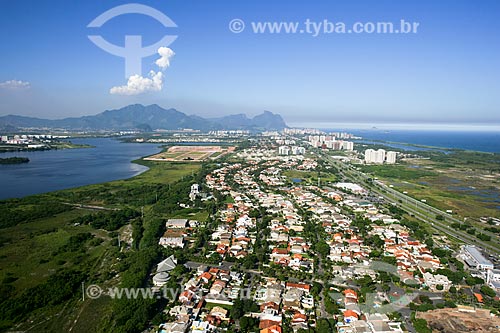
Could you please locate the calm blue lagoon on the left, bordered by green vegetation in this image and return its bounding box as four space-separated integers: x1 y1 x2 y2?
0 138 160 199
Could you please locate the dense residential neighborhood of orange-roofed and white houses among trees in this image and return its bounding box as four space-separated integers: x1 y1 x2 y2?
155 133 500 333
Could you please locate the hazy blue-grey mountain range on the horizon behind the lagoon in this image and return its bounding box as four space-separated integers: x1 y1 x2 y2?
0 104 287 131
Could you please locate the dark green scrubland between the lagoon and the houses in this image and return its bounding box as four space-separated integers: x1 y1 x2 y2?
0 162 208 332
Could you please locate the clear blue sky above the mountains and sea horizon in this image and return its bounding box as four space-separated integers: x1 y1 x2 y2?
0 0 500 127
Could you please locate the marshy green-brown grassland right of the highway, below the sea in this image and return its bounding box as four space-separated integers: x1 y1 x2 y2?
360 151 500 218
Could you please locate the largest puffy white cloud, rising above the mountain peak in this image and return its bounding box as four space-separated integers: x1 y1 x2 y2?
109 47 175 95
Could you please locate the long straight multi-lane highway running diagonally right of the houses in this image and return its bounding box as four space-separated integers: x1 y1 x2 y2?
322 154 500 256
